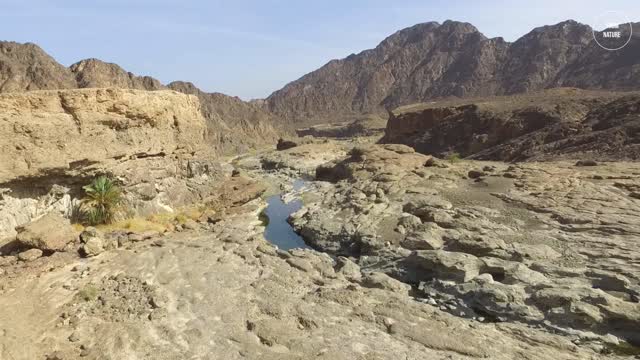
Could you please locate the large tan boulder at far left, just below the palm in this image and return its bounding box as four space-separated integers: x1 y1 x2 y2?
16 213 78 251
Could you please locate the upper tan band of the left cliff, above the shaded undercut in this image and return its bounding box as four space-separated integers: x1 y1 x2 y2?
0 89 206 182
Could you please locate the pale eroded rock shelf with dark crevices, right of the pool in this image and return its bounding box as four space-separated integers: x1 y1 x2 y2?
284 145 640 349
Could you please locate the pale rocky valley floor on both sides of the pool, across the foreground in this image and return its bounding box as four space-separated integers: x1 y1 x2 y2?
0 142 640 360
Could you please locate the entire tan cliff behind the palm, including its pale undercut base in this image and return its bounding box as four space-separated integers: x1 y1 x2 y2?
0 89 224 244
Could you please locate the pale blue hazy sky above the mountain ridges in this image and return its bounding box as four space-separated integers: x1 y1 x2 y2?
0 0 640 100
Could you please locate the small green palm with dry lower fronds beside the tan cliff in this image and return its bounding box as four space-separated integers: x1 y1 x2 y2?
80 176 122 225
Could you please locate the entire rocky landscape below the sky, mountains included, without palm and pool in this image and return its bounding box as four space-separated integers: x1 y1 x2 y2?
0 16 640 360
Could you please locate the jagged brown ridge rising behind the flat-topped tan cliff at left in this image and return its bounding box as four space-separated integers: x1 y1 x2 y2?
0 42 281 153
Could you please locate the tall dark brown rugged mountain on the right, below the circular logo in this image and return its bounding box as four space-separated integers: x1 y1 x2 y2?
266 20 640 124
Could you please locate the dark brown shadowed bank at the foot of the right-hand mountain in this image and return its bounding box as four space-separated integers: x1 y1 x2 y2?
382 88 640 161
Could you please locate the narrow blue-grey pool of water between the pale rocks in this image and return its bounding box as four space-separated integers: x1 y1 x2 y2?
264 180 309 250
